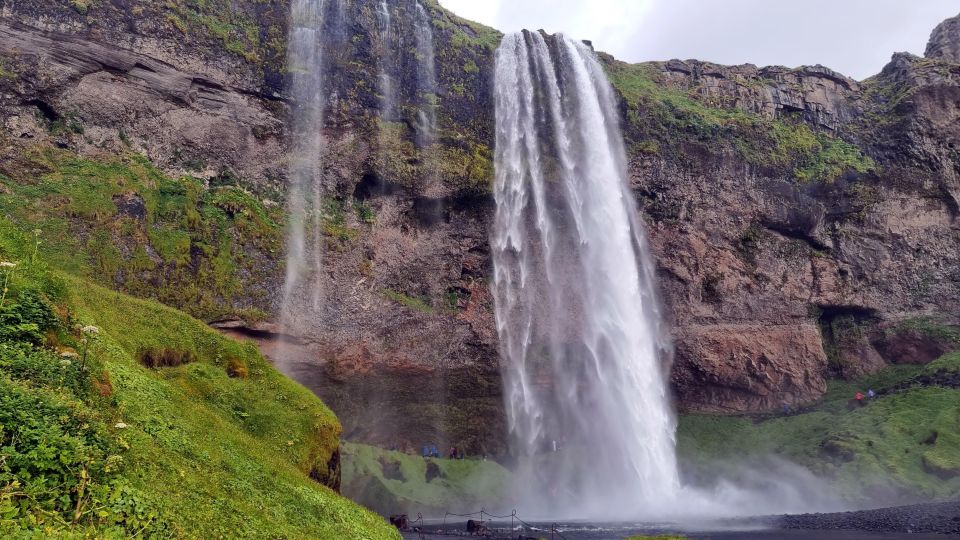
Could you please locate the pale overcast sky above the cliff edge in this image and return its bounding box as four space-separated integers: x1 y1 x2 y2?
440 0 960 80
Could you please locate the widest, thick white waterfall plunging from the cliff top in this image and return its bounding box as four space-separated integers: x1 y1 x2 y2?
491 31 680 519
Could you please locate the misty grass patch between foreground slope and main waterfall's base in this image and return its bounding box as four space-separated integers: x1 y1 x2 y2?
343 443 510 515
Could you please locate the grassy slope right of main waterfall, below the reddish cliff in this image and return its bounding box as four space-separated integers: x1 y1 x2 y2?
678 353 960 501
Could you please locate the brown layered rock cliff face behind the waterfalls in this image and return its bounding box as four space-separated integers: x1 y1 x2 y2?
0 0 960 452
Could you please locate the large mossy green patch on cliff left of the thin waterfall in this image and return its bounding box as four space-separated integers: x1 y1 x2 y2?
0 147 285 319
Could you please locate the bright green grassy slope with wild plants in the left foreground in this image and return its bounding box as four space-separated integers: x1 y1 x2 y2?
0 238 397 539
